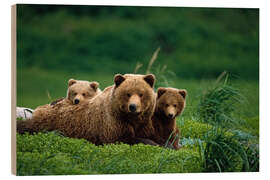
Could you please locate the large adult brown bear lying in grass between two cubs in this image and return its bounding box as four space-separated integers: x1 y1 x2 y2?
17 74 160 145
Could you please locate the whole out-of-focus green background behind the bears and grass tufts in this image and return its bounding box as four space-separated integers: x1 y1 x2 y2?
17 5 259 117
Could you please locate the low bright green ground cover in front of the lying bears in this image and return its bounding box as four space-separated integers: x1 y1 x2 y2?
17 132 202 175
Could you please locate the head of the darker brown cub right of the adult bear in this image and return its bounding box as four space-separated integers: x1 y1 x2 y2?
156 87 187 119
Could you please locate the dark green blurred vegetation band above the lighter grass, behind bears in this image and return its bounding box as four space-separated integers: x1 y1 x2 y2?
17 5 259 80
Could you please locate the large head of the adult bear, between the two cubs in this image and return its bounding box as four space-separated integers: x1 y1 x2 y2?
113 74 155 115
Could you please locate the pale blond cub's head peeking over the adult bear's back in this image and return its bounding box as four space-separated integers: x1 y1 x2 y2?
67 79 100 104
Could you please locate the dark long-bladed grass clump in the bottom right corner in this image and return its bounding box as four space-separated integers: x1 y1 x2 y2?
199 128 259 172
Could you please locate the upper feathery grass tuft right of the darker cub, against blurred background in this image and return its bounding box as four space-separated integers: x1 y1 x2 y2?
198 72 243 128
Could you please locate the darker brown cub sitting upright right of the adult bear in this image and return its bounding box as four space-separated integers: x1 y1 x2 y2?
152 87 187 149
